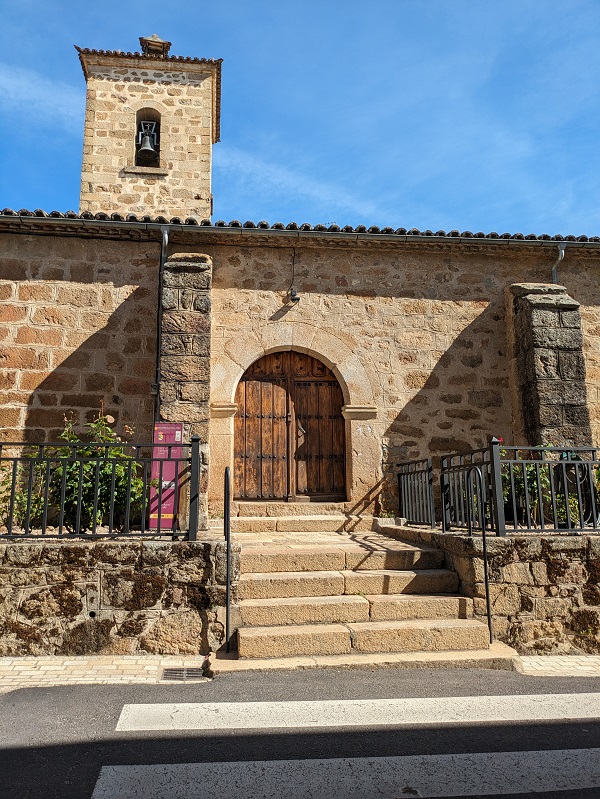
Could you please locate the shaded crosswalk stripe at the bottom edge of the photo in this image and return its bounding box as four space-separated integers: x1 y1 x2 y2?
92 749 600 799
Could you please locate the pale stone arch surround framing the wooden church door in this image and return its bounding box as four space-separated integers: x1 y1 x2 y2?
209 322 385 510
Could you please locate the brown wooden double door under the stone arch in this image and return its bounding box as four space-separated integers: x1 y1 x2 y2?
234 350 346 502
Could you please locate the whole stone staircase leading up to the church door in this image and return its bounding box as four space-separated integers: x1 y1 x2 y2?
227 506 489 658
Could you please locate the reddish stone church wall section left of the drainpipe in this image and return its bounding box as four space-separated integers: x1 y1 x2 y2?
0 234 160 441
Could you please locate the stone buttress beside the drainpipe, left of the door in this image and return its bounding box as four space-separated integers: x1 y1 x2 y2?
159 253 212 530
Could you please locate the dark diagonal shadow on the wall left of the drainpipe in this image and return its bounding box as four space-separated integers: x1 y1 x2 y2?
21 287 156 442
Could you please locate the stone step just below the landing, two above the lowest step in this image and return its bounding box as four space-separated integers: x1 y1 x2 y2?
238 569 458 599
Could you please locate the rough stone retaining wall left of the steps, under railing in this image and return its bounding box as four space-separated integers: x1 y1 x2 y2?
0 540 239 656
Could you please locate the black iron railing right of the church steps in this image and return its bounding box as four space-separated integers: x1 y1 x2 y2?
397 438 600 536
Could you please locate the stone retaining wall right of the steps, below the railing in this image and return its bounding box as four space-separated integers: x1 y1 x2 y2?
394 529 600 654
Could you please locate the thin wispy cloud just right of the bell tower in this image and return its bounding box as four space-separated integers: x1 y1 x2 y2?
213 144 376 222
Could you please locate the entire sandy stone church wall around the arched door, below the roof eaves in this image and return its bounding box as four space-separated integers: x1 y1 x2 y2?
5 227 600 512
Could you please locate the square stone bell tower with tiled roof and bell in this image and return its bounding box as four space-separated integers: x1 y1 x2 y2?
76 34 221 220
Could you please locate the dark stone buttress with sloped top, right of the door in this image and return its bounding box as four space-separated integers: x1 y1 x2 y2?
510 283 592 447
